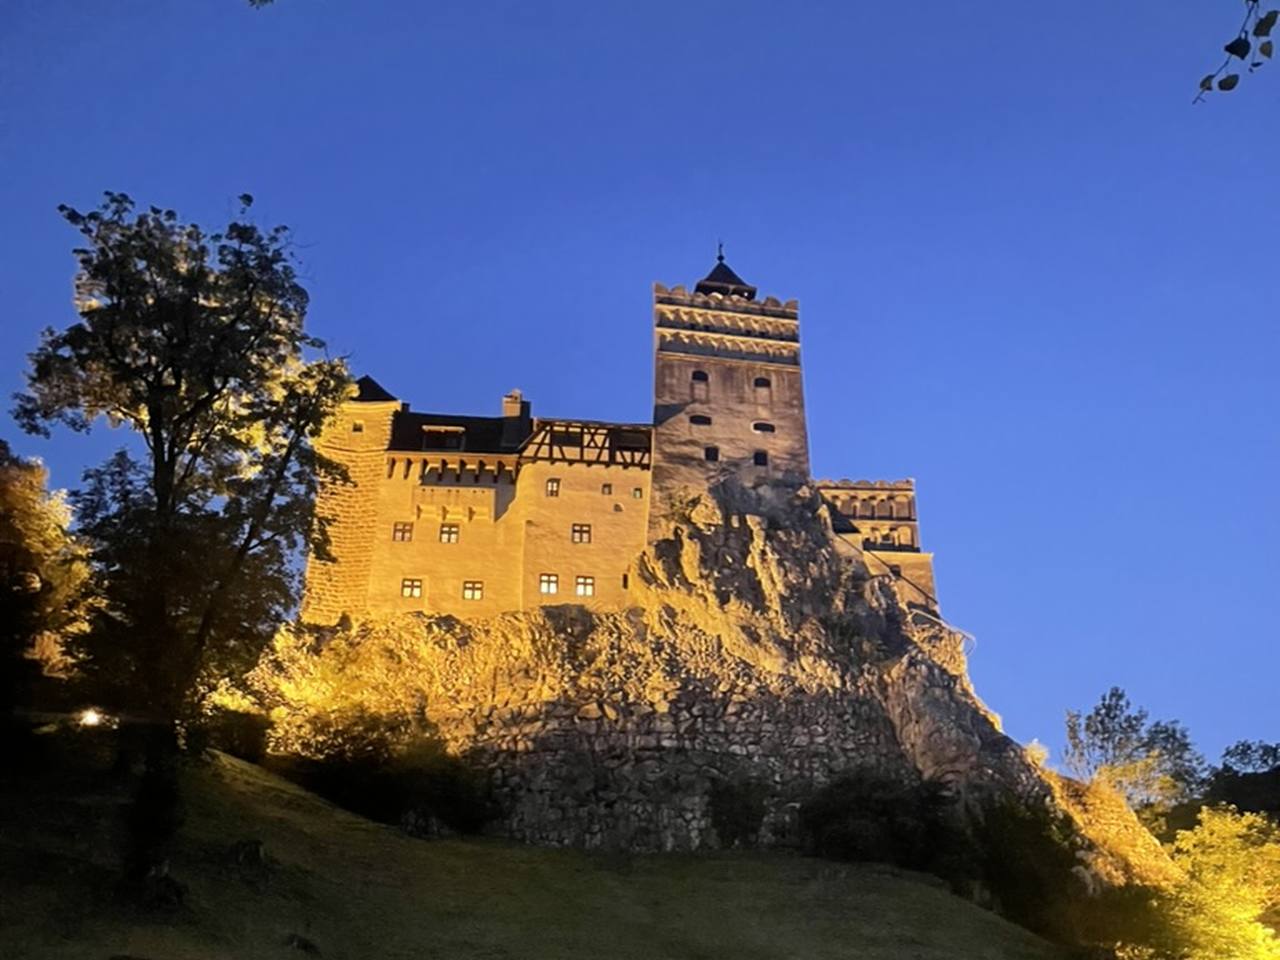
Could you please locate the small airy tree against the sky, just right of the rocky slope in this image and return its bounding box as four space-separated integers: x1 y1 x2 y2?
1065 687 1204 813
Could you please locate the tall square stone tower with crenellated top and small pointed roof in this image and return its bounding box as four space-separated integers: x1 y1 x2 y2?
653 253 809 506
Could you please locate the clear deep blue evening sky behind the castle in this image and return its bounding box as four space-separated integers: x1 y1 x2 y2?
0 0 1280 756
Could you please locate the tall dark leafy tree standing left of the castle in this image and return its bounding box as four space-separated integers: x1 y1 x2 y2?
14 192 349 885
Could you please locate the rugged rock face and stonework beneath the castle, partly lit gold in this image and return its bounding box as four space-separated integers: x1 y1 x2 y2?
253 484 1048 850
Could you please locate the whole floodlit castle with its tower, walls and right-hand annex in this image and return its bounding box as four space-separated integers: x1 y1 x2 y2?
302 256 936 623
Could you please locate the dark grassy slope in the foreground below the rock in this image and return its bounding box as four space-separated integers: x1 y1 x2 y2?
0 756 1061 960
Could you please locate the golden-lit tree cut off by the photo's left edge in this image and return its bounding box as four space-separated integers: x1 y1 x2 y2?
0 440 88 723
